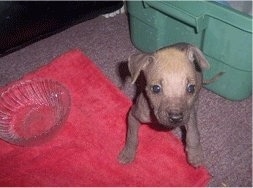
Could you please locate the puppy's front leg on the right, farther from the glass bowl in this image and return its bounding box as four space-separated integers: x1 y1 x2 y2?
186 107 203 167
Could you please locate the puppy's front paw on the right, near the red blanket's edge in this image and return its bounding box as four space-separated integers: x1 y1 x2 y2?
186 146 203 167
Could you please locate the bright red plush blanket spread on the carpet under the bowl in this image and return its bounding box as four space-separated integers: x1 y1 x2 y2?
0 50 209 186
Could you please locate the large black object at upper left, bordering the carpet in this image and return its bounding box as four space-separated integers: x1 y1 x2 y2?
0 1 123 56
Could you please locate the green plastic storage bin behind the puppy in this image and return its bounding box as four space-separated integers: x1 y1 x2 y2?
127 1 252 100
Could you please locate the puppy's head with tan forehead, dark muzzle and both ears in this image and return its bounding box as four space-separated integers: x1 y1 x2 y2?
128 43 209 127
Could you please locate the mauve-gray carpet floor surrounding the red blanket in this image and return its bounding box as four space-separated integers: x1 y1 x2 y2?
0 14 252 187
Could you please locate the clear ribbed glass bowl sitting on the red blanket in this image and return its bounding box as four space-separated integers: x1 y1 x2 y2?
0 79 71 146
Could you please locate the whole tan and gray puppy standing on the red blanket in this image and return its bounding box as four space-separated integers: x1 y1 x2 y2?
118 43 209 167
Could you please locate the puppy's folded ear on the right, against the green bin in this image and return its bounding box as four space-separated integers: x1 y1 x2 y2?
187 45 210 72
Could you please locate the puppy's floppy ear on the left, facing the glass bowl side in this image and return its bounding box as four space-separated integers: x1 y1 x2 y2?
128 54 155 84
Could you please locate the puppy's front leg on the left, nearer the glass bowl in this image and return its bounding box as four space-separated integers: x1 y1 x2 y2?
118 109 140 164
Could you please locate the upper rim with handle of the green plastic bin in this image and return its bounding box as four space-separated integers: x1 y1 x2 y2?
143 0 252 33
